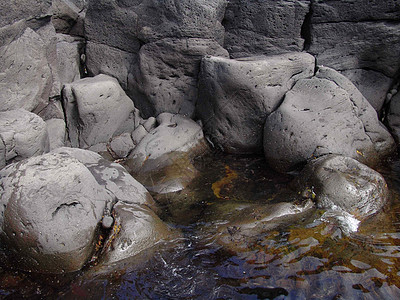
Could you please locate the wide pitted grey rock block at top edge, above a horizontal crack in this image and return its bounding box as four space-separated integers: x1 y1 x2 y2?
85 0 226 52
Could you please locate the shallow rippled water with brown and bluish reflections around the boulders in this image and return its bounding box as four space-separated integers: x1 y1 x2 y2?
0 156 400 299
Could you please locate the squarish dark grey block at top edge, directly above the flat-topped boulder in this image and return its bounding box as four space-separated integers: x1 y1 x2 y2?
223 0 310 58
